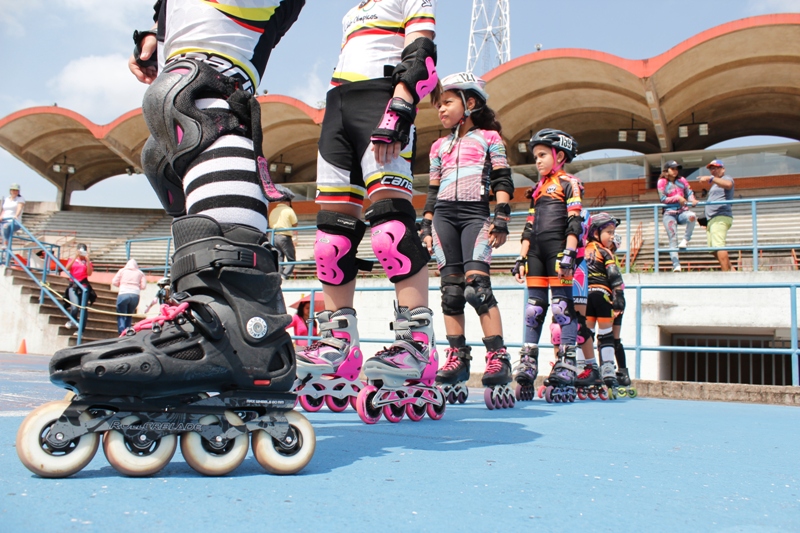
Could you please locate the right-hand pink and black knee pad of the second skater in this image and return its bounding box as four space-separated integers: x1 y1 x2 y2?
364 198 431 283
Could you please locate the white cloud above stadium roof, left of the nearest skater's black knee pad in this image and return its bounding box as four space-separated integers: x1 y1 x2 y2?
47 54 147 123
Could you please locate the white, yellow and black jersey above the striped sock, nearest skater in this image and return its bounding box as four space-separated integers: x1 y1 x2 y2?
158 0 305 92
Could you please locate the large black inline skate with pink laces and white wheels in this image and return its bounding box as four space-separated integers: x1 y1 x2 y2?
16 215 316 478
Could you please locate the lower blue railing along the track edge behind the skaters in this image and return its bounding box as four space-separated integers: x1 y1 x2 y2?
283 283 800 387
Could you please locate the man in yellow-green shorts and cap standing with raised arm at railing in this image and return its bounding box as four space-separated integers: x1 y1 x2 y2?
698 159 734 272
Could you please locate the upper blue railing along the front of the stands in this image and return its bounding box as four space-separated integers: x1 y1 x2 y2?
125 196 800 276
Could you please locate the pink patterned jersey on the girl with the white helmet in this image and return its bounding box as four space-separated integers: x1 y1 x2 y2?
430 128 509 202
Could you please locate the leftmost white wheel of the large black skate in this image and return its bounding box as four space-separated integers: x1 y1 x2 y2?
16 400 100 478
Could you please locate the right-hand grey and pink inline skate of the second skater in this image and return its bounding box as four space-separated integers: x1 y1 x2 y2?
356 303 447 424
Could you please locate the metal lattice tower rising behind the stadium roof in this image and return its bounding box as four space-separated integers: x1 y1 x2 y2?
467 0 511 74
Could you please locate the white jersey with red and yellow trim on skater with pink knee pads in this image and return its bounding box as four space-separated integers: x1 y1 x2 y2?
331 0 435 87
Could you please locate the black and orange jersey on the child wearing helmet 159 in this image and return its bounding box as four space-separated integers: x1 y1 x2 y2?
528 170 583 240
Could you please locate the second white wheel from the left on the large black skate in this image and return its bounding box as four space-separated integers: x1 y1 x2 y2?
103 415 178 477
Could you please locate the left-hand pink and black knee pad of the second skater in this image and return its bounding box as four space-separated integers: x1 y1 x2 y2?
314 211 372 285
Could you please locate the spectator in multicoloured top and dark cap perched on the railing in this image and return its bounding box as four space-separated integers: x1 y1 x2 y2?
658 161 697 272
